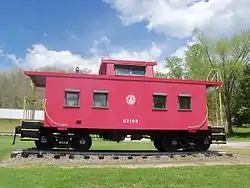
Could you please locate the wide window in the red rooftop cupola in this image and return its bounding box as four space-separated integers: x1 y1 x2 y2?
115 65 146 76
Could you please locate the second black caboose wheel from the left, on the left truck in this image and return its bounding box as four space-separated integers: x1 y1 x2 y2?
71 134 92 151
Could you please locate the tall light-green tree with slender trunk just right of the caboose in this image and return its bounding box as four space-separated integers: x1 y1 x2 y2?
208 32 250 136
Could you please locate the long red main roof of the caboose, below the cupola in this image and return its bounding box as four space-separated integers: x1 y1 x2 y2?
24 71 223 87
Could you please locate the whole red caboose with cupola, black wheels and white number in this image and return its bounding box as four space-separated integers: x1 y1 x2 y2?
12 60 226 151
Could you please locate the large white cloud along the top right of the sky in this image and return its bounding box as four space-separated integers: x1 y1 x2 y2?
104 0 250 38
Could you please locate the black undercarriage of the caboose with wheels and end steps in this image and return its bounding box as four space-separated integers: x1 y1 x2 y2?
13 121 226 152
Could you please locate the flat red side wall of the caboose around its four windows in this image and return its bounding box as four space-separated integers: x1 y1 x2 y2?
45 76 207 130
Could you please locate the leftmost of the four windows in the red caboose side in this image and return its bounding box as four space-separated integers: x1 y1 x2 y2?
64 89 80 107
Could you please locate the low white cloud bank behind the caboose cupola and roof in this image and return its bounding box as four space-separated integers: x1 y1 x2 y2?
4 37 166 73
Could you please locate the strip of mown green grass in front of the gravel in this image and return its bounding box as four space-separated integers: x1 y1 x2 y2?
0 166 250 188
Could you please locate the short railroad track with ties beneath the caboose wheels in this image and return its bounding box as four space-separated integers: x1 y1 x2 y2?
10 148 233 160
